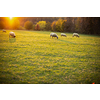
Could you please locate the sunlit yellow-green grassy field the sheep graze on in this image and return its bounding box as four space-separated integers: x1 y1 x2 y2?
0 30 100 84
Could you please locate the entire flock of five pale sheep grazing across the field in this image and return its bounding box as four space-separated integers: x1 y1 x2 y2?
3 29 79 39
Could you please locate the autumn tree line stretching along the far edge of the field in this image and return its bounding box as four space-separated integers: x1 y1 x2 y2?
0 17 100 35
